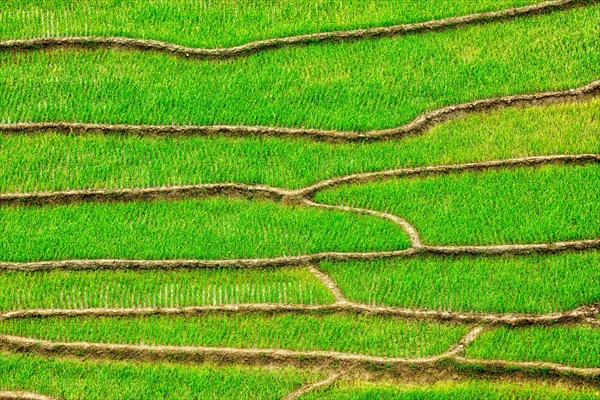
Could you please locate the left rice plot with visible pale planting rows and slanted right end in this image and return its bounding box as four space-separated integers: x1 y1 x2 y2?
0 268 334 310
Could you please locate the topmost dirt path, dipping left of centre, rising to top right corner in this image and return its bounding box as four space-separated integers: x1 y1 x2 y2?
0 0 597 59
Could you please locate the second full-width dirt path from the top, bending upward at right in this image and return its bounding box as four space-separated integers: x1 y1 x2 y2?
0 79 600 142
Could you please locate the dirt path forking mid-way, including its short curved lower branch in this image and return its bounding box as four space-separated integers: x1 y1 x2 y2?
0 154 600 208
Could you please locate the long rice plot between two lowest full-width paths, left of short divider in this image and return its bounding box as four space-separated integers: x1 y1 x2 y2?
0 313 468 357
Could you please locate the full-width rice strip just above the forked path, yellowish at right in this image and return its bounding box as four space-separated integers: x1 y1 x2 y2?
0 98 600 192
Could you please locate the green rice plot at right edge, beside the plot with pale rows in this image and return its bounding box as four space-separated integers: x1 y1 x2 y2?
321 252 600 313
